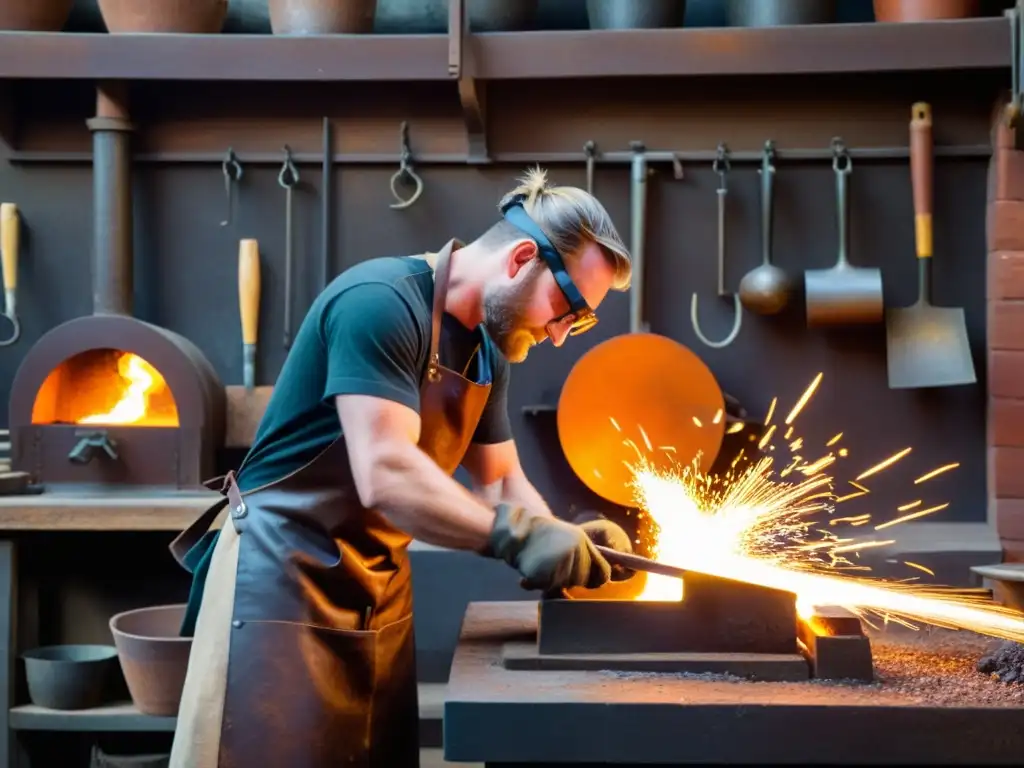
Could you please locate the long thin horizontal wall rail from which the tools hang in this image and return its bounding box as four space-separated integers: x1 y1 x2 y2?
0 144 992 166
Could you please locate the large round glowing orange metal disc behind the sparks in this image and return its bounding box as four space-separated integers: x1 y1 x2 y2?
558 334 726 507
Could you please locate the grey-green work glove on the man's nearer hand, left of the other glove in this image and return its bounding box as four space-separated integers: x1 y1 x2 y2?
483 504 611 592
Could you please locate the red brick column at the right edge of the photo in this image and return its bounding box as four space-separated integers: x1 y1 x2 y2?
987 102 1024 562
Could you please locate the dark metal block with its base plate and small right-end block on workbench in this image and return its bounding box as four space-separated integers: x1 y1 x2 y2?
502 572 873 682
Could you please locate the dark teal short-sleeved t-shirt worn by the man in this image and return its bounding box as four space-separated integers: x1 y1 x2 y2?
239 256 512 490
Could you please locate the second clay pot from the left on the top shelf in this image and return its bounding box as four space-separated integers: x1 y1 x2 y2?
98 0 227 35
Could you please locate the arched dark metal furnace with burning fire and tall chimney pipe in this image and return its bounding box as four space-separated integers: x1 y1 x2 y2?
9 83 226 490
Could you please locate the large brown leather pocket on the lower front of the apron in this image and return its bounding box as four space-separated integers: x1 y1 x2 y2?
221 616 418 768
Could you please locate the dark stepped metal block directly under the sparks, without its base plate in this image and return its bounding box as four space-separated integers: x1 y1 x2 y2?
537 572 797 654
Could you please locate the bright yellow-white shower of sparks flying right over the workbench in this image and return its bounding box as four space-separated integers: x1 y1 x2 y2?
615 374 1024 641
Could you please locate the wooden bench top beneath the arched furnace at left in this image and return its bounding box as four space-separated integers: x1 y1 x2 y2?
0 489 220 531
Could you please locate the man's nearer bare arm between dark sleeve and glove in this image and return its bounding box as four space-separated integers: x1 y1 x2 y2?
335 395 495 552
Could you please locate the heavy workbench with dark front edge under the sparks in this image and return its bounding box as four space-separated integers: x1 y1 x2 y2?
444 602 1024 768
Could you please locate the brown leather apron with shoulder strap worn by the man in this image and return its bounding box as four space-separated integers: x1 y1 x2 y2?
170 241 490 768
